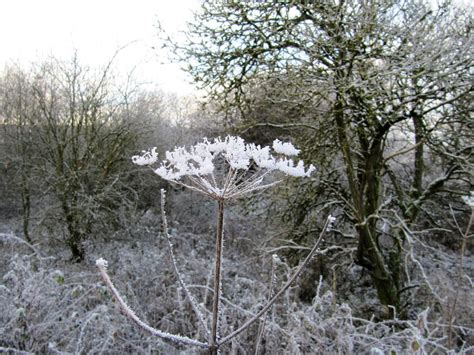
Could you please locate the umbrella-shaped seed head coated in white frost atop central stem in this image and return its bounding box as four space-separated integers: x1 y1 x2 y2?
132 136 315 200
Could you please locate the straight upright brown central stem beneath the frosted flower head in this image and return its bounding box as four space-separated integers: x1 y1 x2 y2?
209 200 224 354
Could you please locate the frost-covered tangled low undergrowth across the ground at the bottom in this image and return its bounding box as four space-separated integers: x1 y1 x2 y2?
0 220 474 354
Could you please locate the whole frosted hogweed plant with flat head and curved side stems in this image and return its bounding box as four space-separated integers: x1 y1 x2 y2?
97 136 334 354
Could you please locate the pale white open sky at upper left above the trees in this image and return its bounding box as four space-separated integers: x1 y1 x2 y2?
0 0 199 94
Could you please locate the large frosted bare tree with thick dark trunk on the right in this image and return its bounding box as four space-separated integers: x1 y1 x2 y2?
161 0 472 314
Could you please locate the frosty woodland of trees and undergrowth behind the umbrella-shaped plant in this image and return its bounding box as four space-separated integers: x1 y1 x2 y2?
0 0 474 354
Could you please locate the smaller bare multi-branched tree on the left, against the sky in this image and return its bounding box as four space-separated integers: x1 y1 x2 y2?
2 56 138 261
